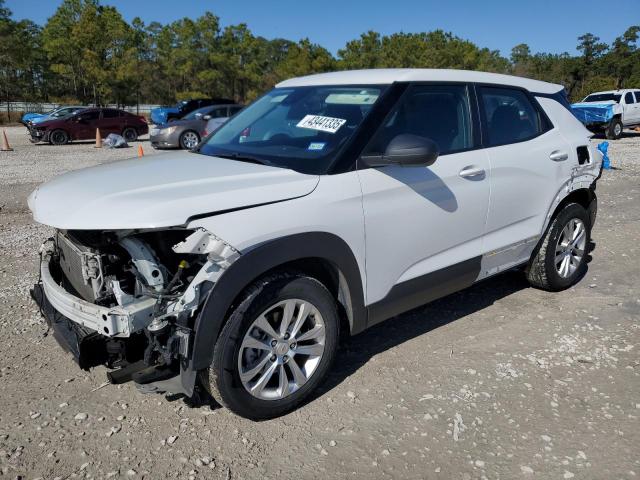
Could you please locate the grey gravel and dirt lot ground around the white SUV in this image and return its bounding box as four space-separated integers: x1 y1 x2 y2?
0 128 640 479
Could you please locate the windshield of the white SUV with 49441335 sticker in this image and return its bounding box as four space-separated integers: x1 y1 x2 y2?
198 86 386 174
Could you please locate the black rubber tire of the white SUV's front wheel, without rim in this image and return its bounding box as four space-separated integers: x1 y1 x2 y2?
200 274 339 420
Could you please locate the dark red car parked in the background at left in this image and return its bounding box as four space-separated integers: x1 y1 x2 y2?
29 108 149 145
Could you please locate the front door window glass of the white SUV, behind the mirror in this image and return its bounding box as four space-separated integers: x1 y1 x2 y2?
364 85 473 155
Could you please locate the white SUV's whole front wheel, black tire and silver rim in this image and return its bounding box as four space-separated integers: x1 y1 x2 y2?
201 274 339 420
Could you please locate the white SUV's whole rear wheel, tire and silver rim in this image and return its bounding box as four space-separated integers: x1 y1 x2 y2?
527 203 591 291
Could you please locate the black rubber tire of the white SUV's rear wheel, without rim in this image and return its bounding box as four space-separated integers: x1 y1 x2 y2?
526 203 591 292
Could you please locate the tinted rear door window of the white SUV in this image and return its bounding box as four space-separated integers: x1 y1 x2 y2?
480 87 543 146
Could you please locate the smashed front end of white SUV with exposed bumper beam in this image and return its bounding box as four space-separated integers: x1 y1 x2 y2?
32 228 240 396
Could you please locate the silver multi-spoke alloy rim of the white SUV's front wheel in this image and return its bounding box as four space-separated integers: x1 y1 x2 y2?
238 299 326 400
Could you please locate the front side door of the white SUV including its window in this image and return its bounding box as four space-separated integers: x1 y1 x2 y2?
358 84 489 323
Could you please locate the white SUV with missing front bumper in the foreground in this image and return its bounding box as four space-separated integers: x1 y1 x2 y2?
29 69 602 419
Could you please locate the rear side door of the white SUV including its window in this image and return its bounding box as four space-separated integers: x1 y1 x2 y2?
478 86 577 275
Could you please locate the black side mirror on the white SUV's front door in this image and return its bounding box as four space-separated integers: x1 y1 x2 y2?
362 133 440 167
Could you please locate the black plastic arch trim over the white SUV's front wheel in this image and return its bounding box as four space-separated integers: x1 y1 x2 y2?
183 232 367 375
